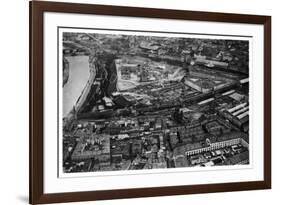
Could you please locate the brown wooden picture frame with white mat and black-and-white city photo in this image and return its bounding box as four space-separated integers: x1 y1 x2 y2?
30 1 271 204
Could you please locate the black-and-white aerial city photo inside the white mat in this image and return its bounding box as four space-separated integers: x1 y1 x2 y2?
59 32 250 173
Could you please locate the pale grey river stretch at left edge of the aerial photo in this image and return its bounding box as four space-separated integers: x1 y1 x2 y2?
63 56 90 117
